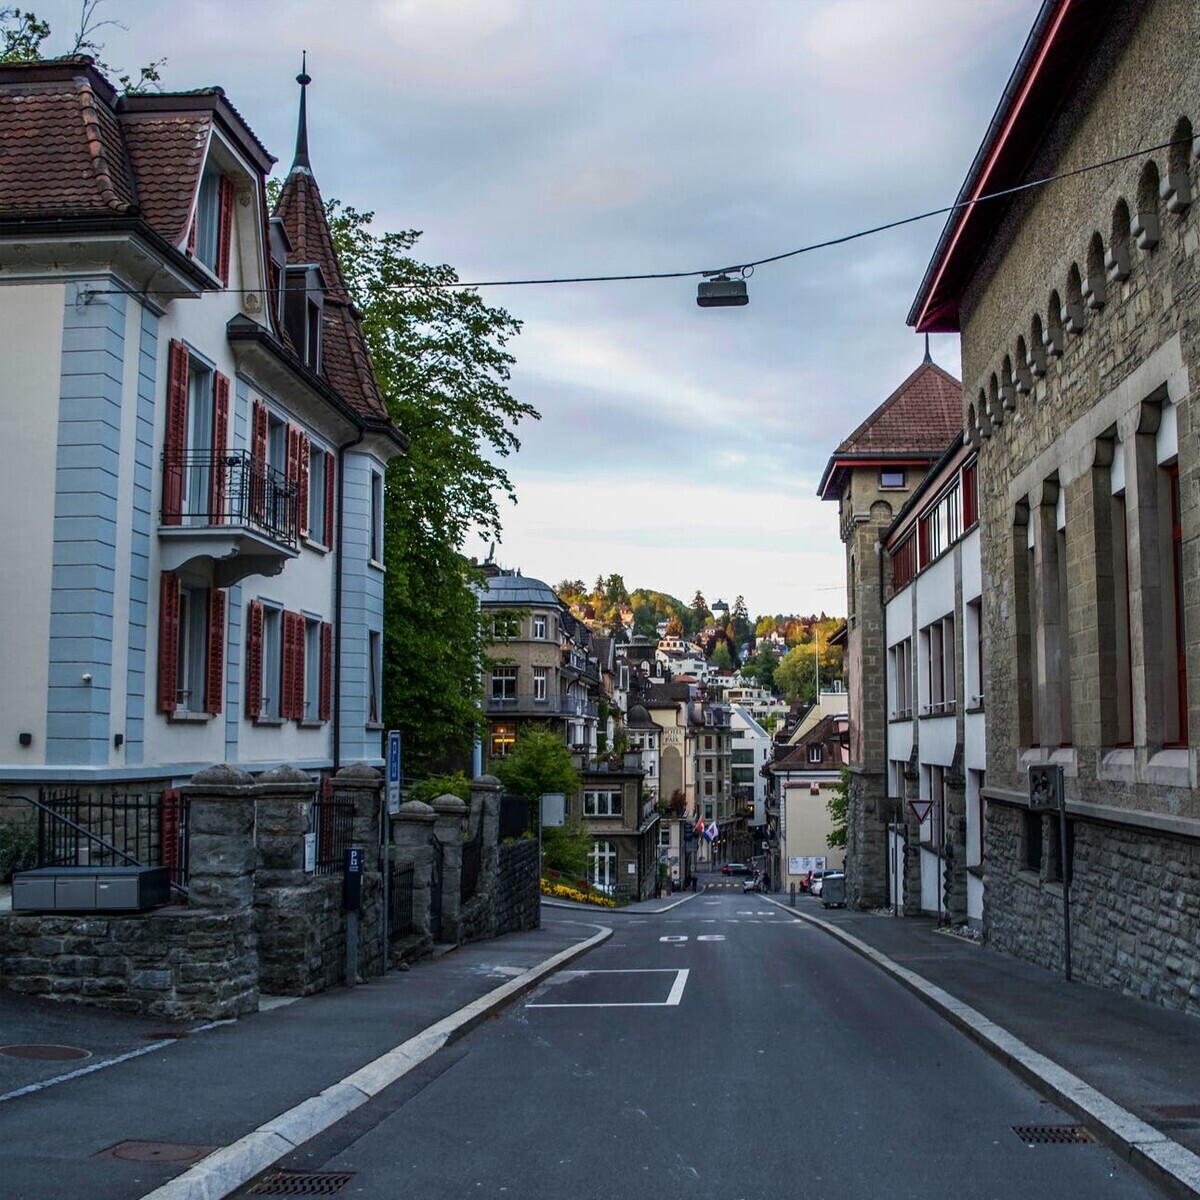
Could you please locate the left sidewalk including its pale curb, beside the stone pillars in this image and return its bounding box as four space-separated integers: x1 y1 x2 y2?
0 911 611 1200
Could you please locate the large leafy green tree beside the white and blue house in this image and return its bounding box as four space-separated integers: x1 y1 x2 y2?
326 199 538 770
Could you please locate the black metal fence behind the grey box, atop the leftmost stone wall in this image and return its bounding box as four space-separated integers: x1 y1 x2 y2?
37 787 188 888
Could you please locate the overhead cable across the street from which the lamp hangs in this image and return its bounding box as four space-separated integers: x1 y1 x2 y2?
90 138 1190 295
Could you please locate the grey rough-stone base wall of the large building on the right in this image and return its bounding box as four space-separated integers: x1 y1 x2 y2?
984 804 1200 1014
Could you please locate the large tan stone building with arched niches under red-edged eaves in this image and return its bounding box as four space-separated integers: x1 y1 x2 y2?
908 0 1200 1012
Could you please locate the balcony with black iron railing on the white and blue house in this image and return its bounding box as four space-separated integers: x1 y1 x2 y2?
158 450 300 588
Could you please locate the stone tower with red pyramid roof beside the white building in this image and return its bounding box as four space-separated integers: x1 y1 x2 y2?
817 354 962 908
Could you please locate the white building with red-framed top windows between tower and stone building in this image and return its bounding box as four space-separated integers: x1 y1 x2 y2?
883 434 986 928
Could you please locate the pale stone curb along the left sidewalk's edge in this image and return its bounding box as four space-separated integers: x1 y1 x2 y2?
142 925 612 1200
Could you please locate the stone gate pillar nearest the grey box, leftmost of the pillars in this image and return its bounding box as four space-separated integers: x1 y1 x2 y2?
180 763 258 910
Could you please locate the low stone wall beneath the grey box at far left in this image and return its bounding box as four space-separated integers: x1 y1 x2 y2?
0 908 258 1020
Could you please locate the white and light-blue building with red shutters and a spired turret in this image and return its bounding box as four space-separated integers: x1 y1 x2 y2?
0 58 404 785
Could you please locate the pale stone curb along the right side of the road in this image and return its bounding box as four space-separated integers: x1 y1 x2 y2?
767 896 1200 1200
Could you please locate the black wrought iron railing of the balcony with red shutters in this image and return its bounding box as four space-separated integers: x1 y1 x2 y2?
162 450 300 547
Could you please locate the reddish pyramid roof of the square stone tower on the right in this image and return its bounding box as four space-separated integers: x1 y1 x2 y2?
817 362 962 500
